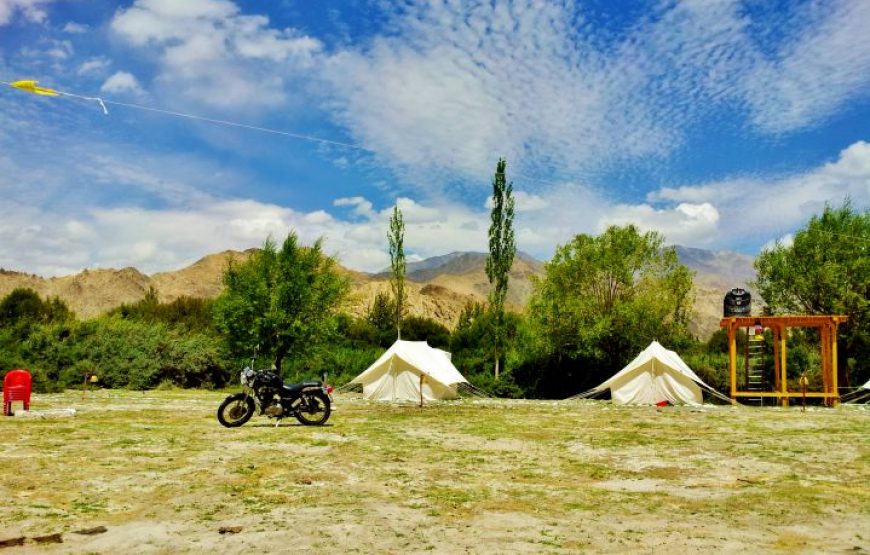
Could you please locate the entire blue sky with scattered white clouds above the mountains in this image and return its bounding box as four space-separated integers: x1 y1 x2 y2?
0 0 870 275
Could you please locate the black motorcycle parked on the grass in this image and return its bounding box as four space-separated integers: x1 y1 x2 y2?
217 353 332 428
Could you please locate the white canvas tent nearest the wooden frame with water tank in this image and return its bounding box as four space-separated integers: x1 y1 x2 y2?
578 341 727 405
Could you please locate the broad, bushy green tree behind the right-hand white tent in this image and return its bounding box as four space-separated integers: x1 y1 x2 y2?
521 225 693 395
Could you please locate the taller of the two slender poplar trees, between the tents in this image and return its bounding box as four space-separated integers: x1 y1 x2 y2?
486 158 517 380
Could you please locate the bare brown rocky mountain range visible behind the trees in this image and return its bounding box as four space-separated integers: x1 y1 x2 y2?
0 247 755 338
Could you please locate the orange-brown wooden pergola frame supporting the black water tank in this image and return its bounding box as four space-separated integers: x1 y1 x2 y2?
719 316 848 407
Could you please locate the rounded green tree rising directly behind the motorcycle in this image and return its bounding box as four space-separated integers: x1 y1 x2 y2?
214 233 349 373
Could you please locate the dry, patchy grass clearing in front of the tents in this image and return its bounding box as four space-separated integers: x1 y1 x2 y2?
0 391 870 555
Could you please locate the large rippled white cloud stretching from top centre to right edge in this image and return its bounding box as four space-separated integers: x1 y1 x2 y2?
323 0 870 190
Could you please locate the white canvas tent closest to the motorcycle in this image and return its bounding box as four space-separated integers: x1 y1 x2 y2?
350 339 468 401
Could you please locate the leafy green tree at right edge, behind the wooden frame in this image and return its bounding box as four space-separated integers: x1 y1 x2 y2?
755 200 870 384
